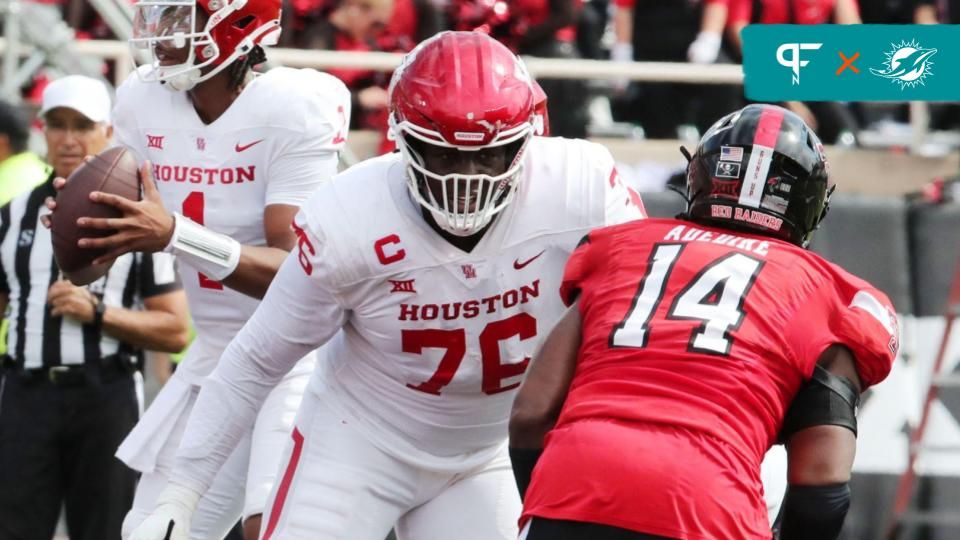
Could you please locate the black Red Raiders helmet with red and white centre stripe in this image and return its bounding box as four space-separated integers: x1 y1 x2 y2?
683 105 833 247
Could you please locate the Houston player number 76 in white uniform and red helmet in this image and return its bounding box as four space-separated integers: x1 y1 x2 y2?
129 32 644 540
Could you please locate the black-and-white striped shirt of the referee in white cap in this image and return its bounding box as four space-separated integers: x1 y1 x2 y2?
0 175 180 369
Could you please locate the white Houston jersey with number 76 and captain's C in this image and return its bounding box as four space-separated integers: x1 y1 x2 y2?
173 138 644 491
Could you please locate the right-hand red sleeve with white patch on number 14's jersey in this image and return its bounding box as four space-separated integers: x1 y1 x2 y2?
787 271 900 390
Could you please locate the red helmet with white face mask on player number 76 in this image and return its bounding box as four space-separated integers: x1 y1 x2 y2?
390 32 545 236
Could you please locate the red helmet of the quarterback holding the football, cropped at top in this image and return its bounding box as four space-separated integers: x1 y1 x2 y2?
130 0 281 90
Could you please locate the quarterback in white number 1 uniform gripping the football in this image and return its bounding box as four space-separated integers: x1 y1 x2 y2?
45 0 350 540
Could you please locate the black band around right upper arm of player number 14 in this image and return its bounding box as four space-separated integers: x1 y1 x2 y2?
779 366 860 443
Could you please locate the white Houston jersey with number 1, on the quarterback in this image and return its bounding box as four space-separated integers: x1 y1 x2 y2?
113 68 350 377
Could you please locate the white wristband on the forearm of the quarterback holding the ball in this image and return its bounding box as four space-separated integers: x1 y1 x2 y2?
164 213 241 281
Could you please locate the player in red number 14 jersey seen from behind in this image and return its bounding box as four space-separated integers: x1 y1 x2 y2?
510 105 898 540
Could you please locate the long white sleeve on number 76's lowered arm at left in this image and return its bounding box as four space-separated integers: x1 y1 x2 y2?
171 243 346 493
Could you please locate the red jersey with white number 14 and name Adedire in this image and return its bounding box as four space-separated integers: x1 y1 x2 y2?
523 219 898 539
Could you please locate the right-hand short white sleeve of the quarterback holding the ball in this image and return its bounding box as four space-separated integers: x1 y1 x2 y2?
266 70 350 206
